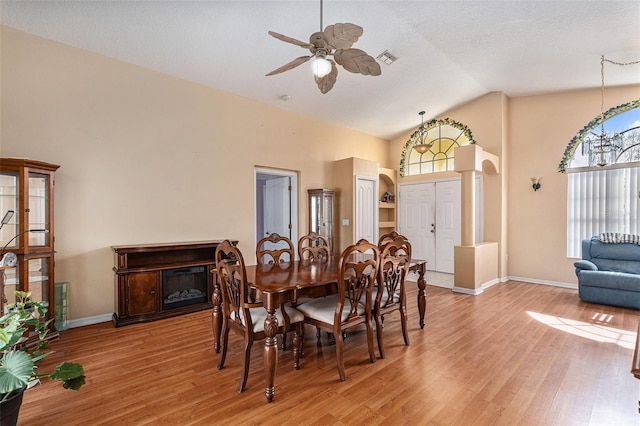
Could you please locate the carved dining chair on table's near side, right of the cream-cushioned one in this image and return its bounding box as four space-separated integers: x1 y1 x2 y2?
373 235 411 358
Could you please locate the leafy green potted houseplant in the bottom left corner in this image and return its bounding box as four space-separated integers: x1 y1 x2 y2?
0 291 85 425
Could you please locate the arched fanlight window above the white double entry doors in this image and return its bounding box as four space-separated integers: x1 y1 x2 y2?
400 118 476 176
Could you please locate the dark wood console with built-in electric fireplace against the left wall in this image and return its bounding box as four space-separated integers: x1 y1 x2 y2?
111 240 228 327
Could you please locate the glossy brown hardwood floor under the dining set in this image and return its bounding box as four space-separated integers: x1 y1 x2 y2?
18 281 640 426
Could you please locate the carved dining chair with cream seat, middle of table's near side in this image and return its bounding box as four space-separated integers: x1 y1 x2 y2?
296 240 379 381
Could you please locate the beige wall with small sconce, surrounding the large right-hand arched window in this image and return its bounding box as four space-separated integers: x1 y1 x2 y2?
507 86 640 284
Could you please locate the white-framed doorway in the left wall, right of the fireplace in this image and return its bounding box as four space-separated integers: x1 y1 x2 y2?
255 167 298 260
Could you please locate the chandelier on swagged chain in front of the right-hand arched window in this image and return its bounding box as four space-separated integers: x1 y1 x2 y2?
582 55 640 167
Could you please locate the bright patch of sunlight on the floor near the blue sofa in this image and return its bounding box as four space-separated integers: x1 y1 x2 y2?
527 311 636 349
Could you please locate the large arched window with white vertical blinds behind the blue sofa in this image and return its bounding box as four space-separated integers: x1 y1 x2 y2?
558 99 640 258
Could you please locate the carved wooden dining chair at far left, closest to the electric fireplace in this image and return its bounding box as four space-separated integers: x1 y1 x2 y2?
216 240 304 392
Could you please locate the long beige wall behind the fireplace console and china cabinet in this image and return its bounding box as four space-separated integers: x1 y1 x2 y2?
0 27 388 319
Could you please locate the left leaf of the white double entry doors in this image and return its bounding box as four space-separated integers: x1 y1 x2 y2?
398 183 436 270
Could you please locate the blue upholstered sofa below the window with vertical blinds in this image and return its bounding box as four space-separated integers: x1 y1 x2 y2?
574 237 640 309
